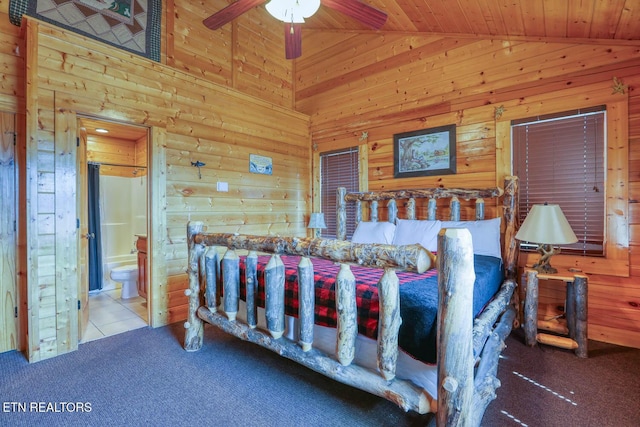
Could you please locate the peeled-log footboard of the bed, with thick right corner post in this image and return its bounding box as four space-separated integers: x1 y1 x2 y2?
184 223 502 425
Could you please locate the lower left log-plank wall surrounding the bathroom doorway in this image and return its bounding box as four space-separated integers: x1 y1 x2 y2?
18 19 310 360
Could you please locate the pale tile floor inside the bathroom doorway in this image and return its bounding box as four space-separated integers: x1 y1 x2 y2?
81 288 148 343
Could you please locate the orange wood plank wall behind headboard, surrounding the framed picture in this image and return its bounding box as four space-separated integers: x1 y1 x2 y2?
296 31 640 347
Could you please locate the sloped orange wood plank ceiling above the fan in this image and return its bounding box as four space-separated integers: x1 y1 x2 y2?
304 0 640 41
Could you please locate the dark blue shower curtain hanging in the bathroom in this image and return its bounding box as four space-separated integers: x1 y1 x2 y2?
87 163 102 291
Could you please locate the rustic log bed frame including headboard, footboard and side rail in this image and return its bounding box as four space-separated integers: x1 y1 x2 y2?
184 177 518 426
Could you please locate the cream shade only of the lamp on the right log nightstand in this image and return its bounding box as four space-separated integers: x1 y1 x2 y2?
516 203 578 245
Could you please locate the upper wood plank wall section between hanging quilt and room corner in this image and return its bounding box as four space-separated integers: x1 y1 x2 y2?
163 0 294 108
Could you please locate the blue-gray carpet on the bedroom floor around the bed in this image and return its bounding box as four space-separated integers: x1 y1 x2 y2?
0 324 640 427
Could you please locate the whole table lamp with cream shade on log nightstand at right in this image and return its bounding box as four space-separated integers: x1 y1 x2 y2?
516 203 578 274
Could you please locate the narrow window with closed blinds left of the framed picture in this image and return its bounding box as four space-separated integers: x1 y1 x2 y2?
320 147 359 239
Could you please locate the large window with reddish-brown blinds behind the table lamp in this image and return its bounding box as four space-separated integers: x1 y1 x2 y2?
511 107 607 256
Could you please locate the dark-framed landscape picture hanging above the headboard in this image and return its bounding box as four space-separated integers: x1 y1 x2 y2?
393 125 456 178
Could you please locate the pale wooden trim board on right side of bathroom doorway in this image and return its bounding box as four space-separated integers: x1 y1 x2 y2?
147 127 166 327
